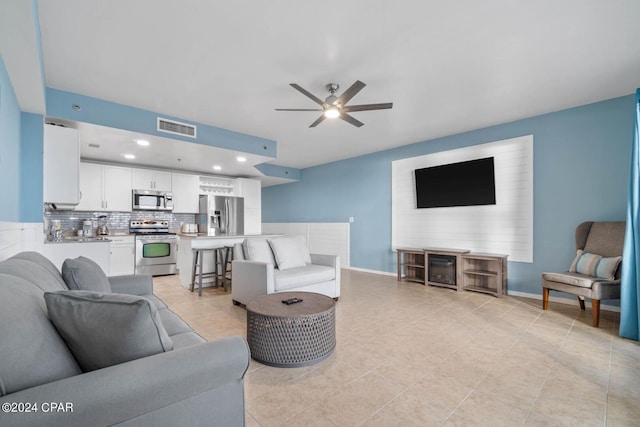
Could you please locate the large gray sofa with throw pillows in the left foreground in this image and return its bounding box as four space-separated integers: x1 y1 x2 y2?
0 252 250 426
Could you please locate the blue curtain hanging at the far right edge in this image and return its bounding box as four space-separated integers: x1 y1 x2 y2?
620 89 640 340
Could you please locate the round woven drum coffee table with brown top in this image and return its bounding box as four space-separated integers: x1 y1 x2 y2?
247 292 336 368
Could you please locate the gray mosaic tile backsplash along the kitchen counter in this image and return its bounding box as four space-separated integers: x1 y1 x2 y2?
44 211 196 231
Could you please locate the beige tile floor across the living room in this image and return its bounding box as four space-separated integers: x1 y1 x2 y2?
154 270 640 427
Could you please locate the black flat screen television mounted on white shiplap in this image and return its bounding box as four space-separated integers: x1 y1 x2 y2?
414 157 496 209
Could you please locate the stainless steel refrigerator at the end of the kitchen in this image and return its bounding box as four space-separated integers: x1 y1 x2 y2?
198 195 244 236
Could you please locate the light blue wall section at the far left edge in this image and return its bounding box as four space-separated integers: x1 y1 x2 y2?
0 56 22 222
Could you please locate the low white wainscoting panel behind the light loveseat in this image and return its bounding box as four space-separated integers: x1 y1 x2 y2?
262 222 350 267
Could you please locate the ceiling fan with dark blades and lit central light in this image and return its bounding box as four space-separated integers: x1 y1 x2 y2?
276 80 393 128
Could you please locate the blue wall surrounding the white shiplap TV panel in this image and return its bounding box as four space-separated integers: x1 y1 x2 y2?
262 95 634 294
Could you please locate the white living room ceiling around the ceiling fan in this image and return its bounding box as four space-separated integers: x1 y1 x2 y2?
3 0 640 172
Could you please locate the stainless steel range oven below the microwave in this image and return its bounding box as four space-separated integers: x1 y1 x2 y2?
129 219 178 276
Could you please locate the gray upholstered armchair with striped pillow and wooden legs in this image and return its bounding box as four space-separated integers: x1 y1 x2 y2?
542 221 625 328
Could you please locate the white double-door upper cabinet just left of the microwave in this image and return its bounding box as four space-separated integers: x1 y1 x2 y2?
76 162 131 212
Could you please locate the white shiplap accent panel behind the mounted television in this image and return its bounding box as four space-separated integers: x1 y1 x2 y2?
391 135 533 262
